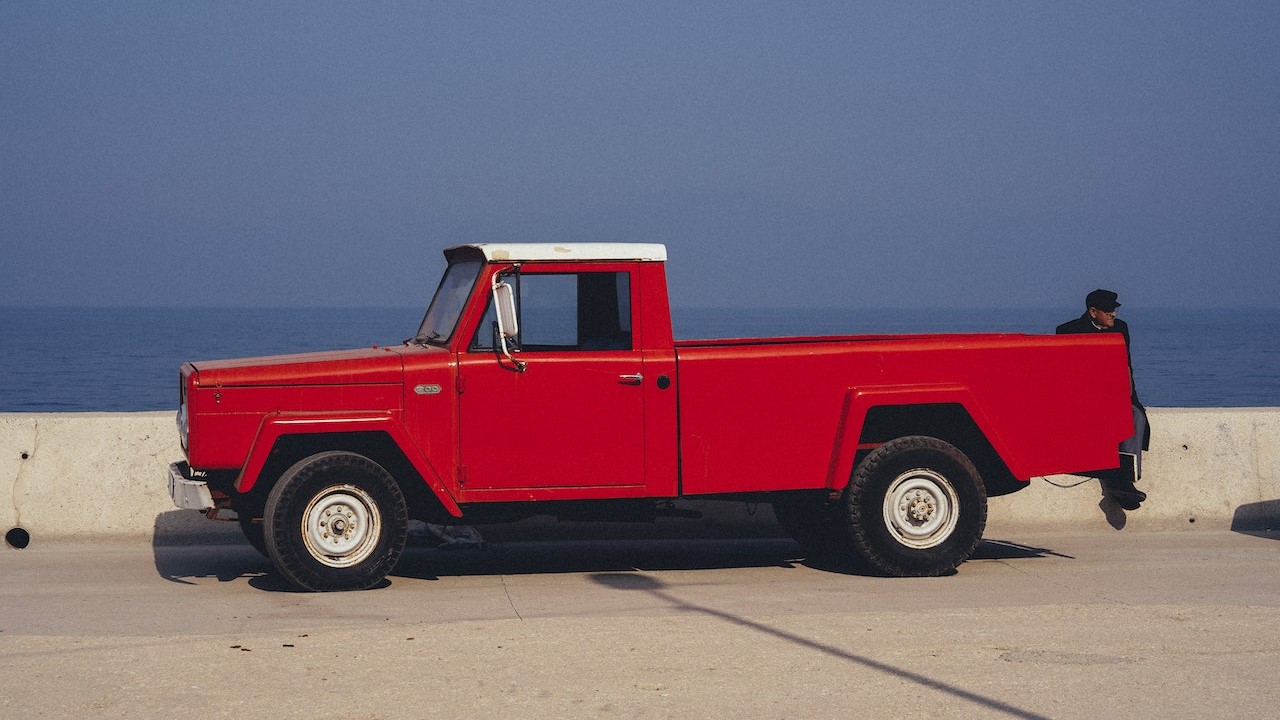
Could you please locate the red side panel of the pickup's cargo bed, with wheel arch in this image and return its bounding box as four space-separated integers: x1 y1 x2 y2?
677 334 1132 495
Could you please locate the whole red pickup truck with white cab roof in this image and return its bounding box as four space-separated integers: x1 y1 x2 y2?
169 243 1133 591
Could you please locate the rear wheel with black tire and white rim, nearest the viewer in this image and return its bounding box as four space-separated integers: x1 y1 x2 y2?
845 436 987 578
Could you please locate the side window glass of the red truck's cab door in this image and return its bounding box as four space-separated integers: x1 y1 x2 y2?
471 273 631 352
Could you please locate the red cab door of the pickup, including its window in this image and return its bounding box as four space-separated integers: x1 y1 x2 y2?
458 264 649 502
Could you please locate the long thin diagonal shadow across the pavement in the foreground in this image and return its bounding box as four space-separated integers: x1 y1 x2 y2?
591 573 1048 720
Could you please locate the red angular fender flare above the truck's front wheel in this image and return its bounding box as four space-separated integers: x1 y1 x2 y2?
236 415 462 518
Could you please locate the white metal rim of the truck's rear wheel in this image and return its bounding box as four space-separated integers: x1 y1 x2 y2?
884 468 960 550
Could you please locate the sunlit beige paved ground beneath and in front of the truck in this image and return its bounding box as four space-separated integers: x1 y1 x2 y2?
0 532 1280 720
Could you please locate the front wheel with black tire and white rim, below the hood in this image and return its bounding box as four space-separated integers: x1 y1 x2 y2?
262 451 408 592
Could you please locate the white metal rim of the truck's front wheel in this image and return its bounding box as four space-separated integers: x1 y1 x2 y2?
302 484 383 568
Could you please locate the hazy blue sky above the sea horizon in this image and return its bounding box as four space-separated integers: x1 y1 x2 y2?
0 0 1280 307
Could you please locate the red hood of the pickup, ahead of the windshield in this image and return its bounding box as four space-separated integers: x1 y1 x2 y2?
191 347 403 387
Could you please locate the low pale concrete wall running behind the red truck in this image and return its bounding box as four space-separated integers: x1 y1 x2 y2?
0 409 1280 547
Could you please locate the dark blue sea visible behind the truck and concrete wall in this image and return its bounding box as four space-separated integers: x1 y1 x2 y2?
0 307 1280 413
